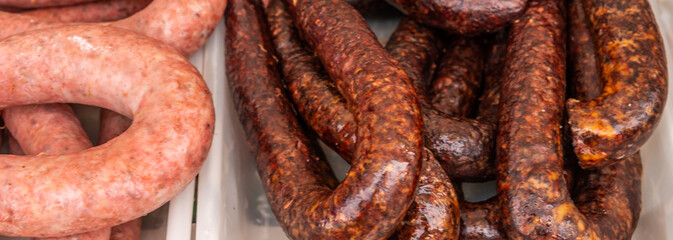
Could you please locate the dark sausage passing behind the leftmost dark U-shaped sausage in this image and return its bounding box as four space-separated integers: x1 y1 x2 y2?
266 0 459 239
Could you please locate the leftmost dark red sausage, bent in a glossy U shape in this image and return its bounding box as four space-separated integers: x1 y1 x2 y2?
226 0 422 239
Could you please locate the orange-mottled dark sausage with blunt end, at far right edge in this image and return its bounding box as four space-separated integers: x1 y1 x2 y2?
567 0 668 168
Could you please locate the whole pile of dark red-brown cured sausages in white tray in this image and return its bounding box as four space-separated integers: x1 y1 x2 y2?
225 0 668 239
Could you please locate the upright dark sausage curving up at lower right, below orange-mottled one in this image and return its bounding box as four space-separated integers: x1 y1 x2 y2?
497 0 641 239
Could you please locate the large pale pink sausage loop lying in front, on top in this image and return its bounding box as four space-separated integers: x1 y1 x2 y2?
0 25 214 237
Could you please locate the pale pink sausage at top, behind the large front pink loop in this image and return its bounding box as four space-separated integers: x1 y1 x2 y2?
0 0 227 56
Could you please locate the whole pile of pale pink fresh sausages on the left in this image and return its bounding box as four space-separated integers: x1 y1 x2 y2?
0 0 222 240
